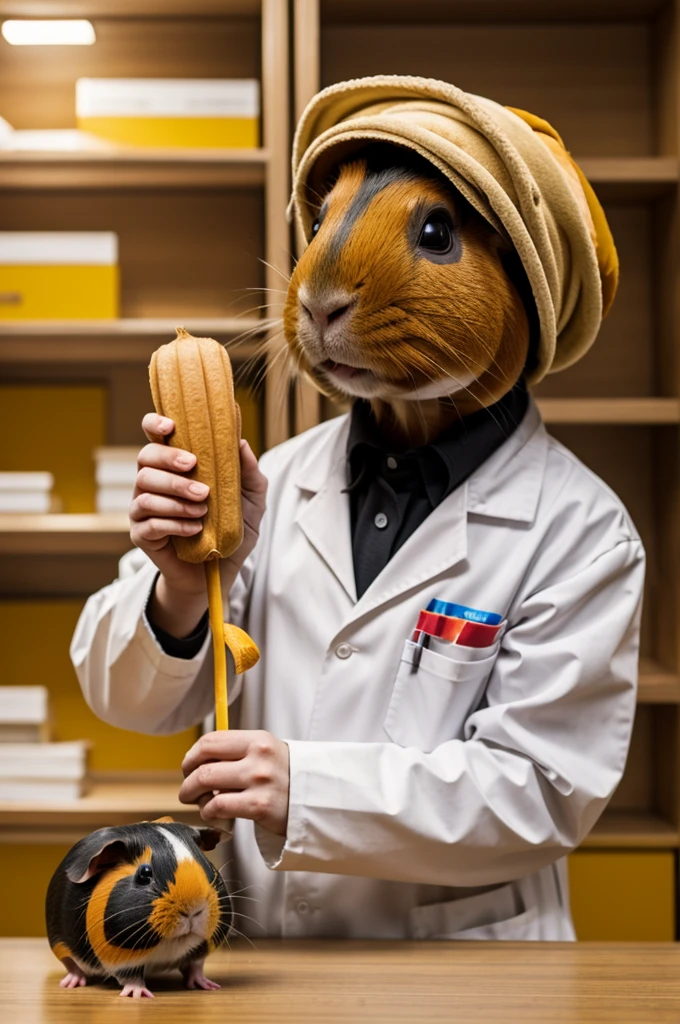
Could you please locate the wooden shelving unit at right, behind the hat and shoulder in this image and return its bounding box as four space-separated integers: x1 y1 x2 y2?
294 0 680 937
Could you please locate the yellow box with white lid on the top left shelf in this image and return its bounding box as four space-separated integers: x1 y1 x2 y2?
76 78 259 150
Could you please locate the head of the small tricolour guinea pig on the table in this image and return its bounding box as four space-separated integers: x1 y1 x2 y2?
67 818 231 973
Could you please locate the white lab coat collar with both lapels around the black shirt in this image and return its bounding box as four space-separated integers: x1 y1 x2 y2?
295 401 547 618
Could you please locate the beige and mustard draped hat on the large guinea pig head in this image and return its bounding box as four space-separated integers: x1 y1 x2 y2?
289 75 619 383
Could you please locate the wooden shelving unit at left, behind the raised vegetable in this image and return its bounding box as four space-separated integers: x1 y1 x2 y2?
0 0 291 928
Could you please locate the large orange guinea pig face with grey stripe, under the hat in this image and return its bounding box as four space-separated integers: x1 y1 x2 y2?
284 154 529 408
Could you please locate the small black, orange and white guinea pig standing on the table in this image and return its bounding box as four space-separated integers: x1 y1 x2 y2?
45 817 232 996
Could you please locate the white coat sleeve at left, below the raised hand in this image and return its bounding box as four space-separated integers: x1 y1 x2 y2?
71 551 258 734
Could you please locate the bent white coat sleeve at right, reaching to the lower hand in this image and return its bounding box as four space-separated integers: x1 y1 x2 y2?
256 539 644 886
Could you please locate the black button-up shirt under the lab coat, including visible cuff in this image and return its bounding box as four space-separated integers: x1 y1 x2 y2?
146 381 528 658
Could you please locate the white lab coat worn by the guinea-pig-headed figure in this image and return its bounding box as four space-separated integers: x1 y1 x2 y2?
72 395 644 939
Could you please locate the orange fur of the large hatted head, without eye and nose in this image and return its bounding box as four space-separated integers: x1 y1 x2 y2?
284 161 528 442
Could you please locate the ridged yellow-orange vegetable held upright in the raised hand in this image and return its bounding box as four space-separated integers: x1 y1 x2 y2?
148 328 243 562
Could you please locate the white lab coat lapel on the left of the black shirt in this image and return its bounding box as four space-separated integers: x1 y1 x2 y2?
296 423 356 603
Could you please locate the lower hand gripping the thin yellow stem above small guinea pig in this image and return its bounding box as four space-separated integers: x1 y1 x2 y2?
179 729 290 836
